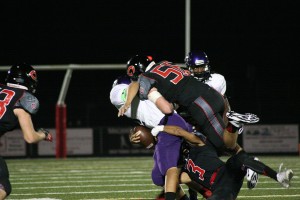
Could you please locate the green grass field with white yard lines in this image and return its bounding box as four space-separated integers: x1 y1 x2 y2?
6 156 300 200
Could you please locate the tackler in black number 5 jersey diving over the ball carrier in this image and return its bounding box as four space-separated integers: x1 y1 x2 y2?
118 56 258 155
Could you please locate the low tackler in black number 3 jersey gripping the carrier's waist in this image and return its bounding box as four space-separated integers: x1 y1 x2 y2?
151 126 293 200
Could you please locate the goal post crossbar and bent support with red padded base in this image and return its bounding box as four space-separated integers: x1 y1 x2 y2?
0 64 124 158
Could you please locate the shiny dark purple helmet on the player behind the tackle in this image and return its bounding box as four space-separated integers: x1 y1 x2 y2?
185 51 210 81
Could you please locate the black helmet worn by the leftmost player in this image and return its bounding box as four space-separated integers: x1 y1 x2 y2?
5 63 38 93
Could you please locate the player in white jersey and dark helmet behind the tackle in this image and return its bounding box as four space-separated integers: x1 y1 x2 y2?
185 50 258 189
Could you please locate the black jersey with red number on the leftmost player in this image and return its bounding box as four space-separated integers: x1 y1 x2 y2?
0 85 39 136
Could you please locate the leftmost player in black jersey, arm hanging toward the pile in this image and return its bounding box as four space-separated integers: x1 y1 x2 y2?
0 63 52 199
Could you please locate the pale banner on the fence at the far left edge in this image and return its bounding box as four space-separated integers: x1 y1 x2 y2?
0 130 26 156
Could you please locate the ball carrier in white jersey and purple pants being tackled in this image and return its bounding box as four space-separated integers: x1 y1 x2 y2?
110 55 192 200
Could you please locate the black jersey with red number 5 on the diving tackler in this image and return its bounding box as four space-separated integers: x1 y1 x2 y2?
139 61 210 106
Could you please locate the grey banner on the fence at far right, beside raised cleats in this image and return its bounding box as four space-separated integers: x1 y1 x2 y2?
242 125 299 153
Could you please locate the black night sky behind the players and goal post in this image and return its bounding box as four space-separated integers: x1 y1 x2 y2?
0 0 300 127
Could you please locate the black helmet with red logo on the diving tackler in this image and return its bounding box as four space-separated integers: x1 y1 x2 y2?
126 55 153 81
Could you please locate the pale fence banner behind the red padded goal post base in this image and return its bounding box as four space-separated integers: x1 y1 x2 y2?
38 128 93 156
